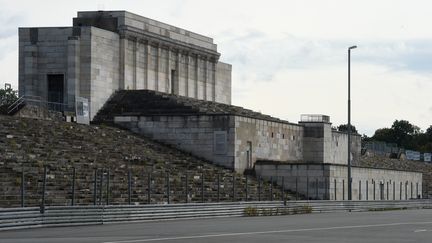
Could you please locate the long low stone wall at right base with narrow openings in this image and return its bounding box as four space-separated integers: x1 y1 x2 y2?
256 162 422 200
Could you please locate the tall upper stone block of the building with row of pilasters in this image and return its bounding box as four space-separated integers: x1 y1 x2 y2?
19 11 231 119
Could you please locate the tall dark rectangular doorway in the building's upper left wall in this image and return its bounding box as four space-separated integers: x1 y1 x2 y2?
48 74 64 111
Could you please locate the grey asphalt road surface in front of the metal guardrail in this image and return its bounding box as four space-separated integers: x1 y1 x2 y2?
0 209 432 243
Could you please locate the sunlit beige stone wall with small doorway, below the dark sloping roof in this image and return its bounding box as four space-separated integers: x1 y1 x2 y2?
235 116 303 171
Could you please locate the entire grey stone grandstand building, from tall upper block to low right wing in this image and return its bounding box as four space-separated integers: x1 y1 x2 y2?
19 11 422 200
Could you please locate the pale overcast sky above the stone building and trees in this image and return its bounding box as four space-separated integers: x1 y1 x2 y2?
0 0 432 135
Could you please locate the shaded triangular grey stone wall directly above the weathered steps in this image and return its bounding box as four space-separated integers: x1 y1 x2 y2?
114 115 235 168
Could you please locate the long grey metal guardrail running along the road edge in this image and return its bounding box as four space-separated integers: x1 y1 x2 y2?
0 199 432 233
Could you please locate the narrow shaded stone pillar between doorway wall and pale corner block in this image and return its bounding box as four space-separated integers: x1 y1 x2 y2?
65 36 80 110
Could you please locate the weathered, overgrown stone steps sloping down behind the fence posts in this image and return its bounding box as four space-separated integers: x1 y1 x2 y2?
0 115 294 207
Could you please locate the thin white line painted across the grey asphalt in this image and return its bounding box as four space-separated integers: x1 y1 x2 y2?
103 222 432 243
